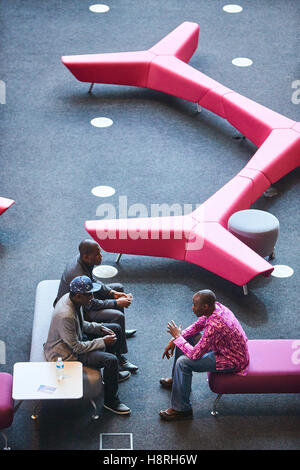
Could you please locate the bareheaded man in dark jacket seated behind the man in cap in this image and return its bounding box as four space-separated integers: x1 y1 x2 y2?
53 239 138 372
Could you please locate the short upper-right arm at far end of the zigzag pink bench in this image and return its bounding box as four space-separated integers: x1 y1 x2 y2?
149 21 200 62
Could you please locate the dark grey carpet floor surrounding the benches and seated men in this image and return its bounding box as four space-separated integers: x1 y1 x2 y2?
0 0 300 450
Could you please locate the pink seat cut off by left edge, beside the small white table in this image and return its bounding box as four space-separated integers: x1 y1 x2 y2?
0 372 14 450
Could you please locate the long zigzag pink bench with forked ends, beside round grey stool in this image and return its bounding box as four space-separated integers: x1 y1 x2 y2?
62 22 300 292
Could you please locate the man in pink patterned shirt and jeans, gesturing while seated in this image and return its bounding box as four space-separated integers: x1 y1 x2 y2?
159 289 249 421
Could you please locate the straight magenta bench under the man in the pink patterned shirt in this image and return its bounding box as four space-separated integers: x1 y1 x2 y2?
207 339 300 416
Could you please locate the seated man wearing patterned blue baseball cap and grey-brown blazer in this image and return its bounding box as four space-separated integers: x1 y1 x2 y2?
44 276 131 415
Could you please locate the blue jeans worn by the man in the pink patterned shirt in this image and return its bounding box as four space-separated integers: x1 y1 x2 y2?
171 338 234 411
